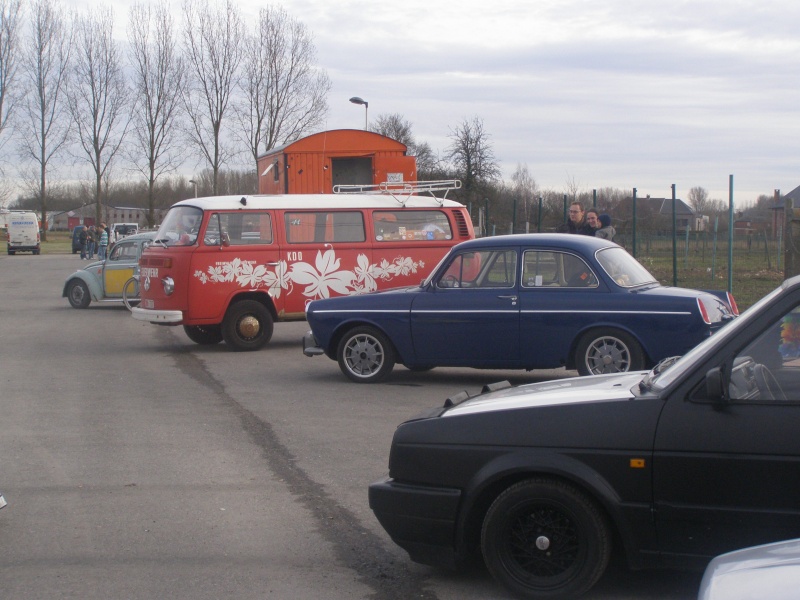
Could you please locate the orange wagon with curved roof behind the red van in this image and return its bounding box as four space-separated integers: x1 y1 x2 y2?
258 129 417 194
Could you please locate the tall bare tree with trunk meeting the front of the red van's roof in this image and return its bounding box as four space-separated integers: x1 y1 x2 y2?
183 0 244 195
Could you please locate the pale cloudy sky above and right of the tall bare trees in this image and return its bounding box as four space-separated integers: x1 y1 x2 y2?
65 0 800 206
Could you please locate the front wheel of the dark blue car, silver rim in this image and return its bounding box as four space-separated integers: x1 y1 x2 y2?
336 326 395 383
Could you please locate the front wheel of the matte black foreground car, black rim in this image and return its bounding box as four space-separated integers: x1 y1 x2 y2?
481 479 611 600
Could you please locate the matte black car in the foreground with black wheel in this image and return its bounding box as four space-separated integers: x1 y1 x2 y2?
369 277 800 600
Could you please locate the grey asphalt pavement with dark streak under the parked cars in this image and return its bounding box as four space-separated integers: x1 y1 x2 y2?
0 254 699 600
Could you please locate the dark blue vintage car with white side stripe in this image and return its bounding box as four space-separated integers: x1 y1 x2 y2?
303 234 737 383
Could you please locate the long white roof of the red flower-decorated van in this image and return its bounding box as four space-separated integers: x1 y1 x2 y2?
173 194 464 210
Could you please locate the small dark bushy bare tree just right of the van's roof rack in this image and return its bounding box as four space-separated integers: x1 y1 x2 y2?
445 117 500 198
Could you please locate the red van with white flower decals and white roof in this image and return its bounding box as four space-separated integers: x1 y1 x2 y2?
132 182 475 350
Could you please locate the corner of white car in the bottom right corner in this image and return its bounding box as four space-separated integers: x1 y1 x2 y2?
697 539 800 600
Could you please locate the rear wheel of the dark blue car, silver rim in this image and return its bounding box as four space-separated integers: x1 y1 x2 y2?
575 329 645 375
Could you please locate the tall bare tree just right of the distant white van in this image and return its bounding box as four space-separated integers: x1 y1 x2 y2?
18 0 73 240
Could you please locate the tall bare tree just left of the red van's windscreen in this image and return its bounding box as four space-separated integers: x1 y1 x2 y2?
128 0 184 227
